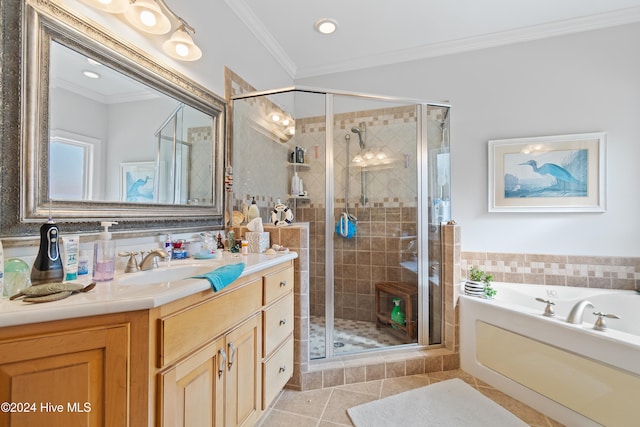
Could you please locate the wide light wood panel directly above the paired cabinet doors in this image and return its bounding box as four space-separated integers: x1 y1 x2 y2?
159 279 262 367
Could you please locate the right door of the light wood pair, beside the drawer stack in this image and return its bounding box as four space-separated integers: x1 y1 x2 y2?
225 315 262 427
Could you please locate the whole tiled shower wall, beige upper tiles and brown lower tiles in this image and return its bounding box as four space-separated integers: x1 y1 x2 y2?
291 106 442 321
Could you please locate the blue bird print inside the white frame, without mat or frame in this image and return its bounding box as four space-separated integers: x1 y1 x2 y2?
504 150 588 198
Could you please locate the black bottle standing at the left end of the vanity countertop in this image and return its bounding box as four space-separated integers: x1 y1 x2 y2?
31 219 64 285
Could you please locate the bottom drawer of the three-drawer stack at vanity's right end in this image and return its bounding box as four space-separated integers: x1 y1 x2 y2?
262 335 293 410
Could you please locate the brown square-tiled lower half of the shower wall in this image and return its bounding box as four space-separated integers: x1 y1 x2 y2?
297 206 417 321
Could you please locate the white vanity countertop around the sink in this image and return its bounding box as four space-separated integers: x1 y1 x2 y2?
0 252 298 327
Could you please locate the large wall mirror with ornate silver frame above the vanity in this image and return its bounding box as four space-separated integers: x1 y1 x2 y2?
2 0 226 235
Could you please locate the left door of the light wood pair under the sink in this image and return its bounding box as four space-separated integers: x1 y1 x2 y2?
160 338 228 427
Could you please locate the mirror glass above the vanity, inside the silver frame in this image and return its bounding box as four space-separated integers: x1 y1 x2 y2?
48 41 214 205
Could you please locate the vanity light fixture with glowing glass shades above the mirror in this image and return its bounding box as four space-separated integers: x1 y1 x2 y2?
81 0 202 61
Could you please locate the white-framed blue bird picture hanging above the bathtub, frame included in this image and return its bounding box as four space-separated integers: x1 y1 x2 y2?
489 132 606 212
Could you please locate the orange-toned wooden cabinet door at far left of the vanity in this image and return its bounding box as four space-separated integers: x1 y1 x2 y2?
0 324 130 427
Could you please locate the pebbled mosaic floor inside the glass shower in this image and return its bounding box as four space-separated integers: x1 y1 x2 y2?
309 316 407 359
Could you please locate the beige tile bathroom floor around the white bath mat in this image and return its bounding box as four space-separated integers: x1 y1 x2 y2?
258 370 562 427
